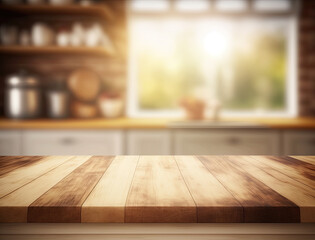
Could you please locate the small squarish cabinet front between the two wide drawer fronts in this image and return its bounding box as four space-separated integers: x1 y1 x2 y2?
127 130 171 155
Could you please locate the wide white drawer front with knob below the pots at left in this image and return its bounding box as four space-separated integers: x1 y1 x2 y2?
22 130 123 155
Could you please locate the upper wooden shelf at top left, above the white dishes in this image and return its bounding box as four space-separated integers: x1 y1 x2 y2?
0 4 114 20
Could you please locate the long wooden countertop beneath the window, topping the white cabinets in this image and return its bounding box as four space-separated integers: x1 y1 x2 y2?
0 118 315 129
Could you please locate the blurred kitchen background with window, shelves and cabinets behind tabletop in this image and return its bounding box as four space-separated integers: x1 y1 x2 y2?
0 0 315 155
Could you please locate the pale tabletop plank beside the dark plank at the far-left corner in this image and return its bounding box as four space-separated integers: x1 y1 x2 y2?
0 156 71 198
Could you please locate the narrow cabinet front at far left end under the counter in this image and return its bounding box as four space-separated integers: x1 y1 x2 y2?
0 130 21 156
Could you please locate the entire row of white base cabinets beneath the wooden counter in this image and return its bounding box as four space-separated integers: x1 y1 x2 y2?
0 125 315 156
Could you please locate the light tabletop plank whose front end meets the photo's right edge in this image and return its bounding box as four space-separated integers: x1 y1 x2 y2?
227 156 315 222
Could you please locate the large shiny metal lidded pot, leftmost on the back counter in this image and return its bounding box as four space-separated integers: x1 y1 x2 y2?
4 71 42 119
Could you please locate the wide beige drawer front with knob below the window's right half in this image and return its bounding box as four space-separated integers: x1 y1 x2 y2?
174 129 280 155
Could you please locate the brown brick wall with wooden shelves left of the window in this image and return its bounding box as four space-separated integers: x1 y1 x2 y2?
0 0 127 116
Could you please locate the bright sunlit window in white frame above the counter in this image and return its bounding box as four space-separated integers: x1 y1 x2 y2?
128 0 297 117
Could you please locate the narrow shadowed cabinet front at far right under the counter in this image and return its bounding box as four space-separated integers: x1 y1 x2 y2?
283 130 315 155
